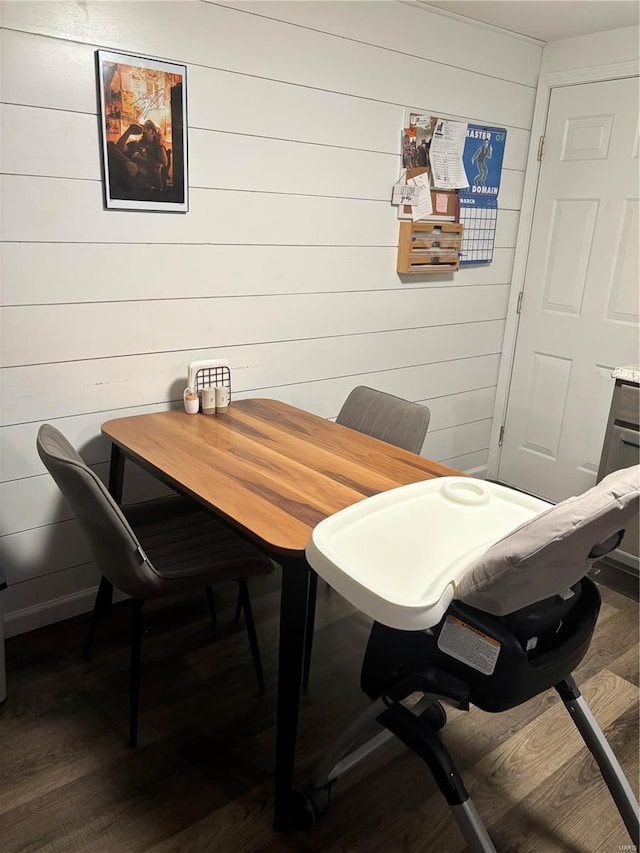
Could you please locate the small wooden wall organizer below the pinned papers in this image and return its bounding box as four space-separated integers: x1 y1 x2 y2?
398 221 463 275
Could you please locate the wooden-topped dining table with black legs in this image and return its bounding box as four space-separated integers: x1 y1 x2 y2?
102 399 459 830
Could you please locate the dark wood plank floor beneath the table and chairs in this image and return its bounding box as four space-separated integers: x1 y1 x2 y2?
0 573 638 853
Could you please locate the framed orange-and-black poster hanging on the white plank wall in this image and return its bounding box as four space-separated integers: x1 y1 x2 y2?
96 50 189 213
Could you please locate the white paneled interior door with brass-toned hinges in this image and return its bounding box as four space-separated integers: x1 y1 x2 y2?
498 77 640 501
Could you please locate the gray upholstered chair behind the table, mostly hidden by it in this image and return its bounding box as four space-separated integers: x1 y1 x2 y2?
302 385 431 687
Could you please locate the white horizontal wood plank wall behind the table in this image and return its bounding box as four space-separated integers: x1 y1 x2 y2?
0 0 541 634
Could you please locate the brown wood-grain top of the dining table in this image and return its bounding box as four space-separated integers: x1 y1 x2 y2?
102 399 459 557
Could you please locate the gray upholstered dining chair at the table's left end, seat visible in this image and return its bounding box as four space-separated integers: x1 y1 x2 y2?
37 424 274 747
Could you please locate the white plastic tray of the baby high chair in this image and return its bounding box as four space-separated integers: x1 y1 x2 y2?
306 477 550 631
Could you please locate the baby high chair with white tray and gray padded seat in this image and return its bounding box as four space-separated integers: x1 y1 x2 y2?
291 466 640 853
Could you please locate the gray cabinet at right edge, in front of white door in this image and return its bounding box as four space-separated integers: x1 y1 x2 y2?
598 374 640 577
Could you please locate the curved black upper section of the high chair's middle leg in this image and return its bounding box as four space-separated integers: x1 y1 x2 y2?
377 704 469 806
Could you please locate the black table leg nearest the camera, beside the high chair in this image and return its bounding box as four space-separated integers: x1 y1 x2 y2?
273 557 309 832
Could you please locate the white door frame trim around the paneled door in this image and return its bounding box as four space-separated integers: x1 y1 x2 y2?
487 60 640 479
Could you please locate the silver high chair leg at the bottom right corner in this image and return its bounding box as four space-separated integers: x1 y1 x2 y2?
556 677 640 850
